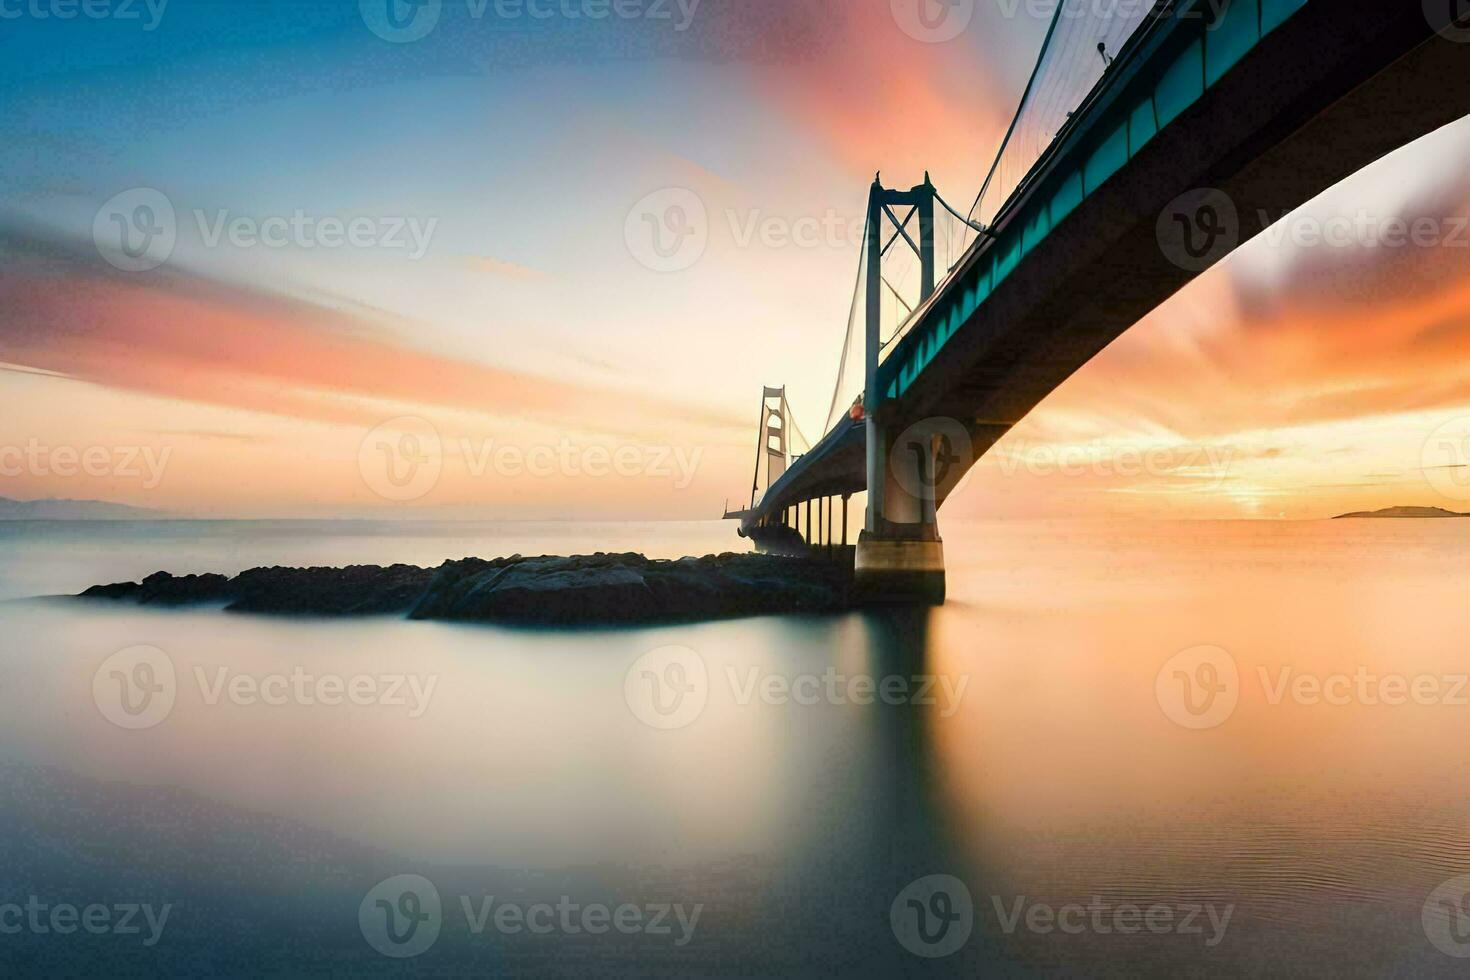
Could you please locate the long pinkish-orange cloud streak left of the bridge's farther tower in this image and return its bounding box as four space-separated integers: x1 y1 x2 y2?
0 221 744 432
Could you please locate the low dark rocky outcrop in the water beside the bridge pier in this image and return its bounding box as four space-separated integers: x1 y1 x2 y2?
79 552 851 626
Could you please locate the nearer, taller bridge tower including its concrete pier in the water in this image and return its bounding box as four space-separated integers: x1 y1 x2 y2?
854 173 945 604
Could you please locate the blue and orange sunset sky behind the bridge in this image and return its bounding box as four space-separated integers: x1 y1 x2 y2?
0 0 1470 520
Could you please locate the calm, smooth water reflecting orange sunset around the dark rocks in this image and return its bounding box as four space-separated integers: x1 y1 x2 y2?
0 520 1470 977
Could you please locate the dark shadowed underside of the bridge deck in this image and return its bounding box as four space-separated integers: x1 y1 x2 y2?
747 0 1470 543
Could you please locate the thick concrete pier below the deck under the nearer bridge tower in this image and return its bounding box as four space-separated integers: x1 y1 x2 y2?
853 423 945 605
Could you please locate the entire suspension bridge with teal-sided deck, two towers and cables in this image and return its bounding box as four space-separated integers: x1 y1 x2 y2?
726 0 1470 602
